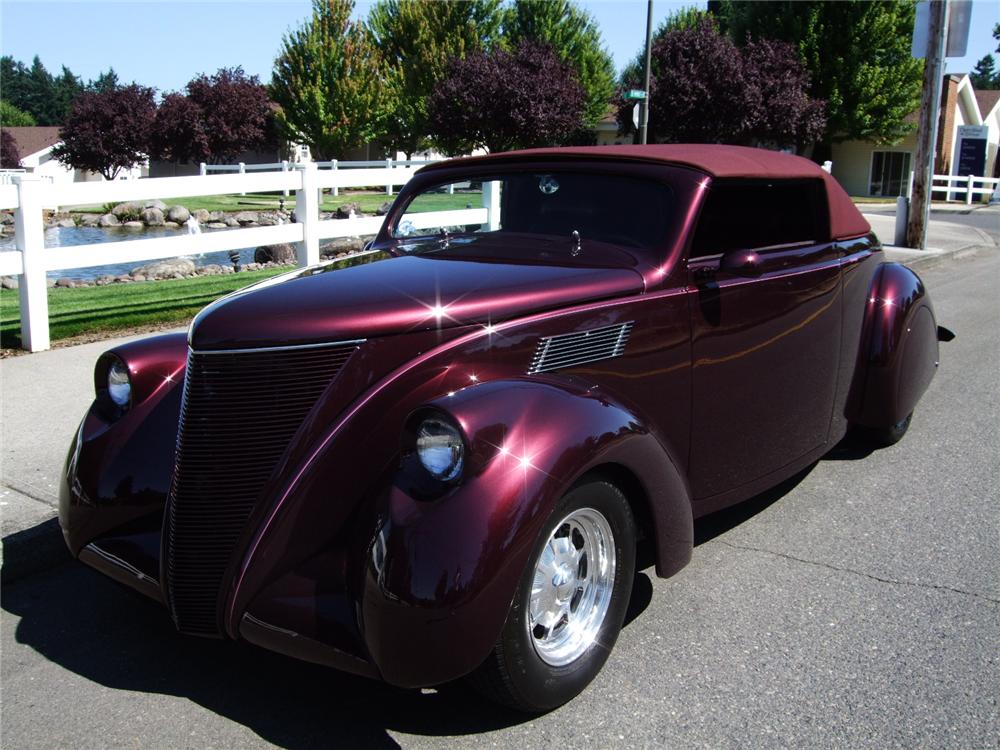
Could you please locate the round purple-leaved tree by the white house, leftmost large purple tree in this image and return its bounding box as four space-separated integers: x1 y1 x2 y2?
52 84 156 180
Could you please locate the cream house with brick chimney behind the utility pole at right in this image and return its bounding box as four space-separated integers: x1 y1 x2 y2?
832 74 1000 198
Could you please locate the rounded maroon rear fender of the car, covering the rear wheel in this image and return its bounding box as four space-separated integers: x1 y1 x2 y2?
847 263 939 427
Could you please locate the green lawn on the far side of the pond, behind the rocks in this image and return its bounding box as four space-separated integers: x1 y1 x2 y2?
70 190 482 214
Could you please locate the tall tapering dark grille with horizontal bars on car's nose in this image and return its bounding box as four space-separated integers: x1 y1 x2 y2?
165 342 360 636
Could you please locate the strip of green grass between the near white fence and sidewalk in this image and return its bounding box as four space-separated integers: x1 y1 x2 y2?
0 268 289 348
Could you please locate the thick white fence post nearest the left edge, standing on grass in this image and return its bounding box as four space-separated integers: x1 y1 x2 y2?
13 174 49 352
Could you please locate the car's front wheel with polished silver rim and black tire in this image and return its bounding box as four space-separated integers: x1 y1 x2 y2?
473 480 635 712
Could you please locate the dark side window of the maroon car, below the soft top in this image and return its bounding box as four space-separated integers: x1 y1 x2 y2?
690 180 830 258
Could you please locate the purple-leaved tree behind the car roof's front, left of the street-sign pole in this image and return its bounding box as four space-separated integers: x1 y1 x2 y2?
428 42 585 154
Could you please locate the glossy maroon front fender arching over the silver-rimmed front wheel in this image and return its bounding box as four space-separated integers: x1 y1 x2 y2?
362 378 693 686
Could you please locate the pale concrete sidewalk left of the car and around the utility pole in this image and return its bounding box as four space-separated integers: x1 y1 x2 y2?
0 214 1000 582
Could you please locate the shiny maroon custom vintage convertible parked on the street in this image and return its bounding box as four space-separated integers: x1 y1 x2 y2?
60 146 938 711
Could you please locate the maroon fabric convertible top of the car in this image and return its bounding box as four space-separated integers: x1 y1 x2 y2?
424 143 871 240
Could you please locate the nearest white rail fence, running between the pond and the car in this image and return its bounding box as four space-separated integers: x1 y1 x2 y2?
0 163 484 352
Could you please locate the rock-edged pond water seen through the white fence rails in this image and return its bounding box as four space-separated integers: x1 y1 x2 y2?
0 227 264 281
